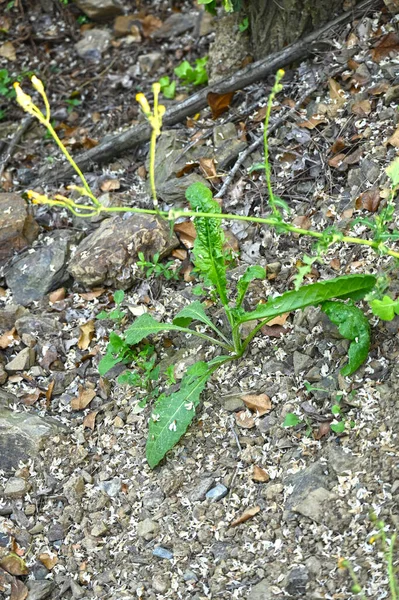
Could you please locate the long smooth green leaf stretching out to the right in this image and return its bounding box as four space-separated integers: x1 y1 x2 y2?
238 275 376 323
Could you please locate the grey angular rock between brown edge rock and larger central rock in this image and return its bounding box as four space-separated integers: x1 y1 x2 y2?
5 231 75 306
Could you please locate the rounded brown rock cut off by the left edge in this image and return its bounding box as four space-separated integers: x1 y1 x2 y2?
0 193 39 267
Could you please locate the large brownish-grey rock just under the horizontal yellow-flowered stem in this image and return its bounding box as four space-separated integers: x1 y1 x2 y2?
68 213 179 290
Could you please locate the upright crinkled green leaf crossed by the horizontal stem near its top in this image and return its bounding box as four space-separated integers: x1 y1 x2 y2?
186 182 228 306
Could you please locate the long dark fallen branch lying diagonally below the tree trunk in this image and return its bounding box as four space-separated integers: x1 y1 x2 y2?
35 0 379 185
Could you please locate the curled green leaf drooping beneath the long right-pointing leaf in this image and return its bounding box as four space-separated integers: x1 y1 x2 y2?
321 302 370 377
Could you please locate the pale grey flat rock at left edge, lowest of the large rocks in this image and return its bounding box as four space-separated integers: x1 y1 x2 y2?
0 405 63 472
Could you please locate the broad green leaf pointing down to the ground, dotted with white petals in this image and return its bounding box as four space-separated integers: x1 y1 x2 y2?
146 362 214 469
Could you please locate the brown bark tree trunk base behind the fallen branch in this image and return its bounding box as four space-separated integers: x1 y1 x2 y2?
245 0 356 60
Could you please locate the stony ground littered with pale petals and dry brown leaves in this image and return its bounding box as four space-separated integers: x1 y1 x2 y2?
0 0 399 600
